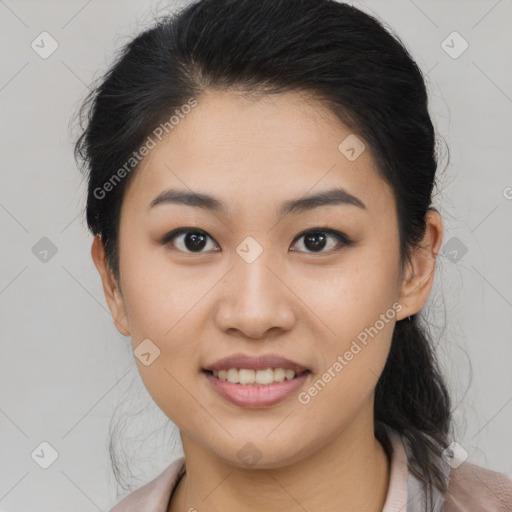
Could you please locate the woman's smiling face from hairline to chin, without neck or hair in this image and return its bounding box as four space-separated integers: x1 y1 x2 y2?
94 92 422 467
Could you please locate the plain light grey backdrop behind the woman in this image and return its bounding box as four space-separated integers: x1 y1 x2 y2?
0 0 512 512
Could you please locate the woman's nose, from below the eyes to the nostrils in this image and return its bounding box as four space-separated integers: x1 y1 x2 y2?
216 251 296 339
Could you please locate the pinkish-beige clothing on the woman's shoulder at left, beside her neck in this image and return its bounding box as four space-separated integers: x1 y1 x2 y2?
110 457 185 512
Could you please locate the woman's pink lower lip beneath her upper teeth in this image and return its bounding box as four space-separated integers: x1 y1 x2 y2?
203 372 310 408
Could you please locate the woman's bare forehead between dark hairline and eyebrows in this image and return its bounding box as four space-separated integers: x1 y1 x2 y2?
125 91 389 216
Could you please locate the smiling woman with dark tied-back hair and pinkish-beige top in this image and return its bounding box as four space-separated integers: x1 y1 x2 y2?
76 0 512 512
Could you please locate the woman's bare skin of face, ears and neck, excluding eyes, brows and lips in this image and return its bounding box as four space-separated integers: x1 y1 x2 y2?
91 91 442 512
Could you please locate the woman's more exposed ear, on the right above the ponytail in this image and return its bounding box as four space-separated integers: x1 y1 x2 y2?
397 210 443 320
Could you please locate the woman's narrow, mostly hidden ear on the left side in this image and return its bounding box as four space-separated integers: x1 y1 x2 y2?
91 236 130 336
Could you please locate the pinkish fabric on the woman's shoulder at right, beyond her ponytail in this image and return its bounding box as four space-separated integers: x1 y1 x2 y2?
443 462 512 512
